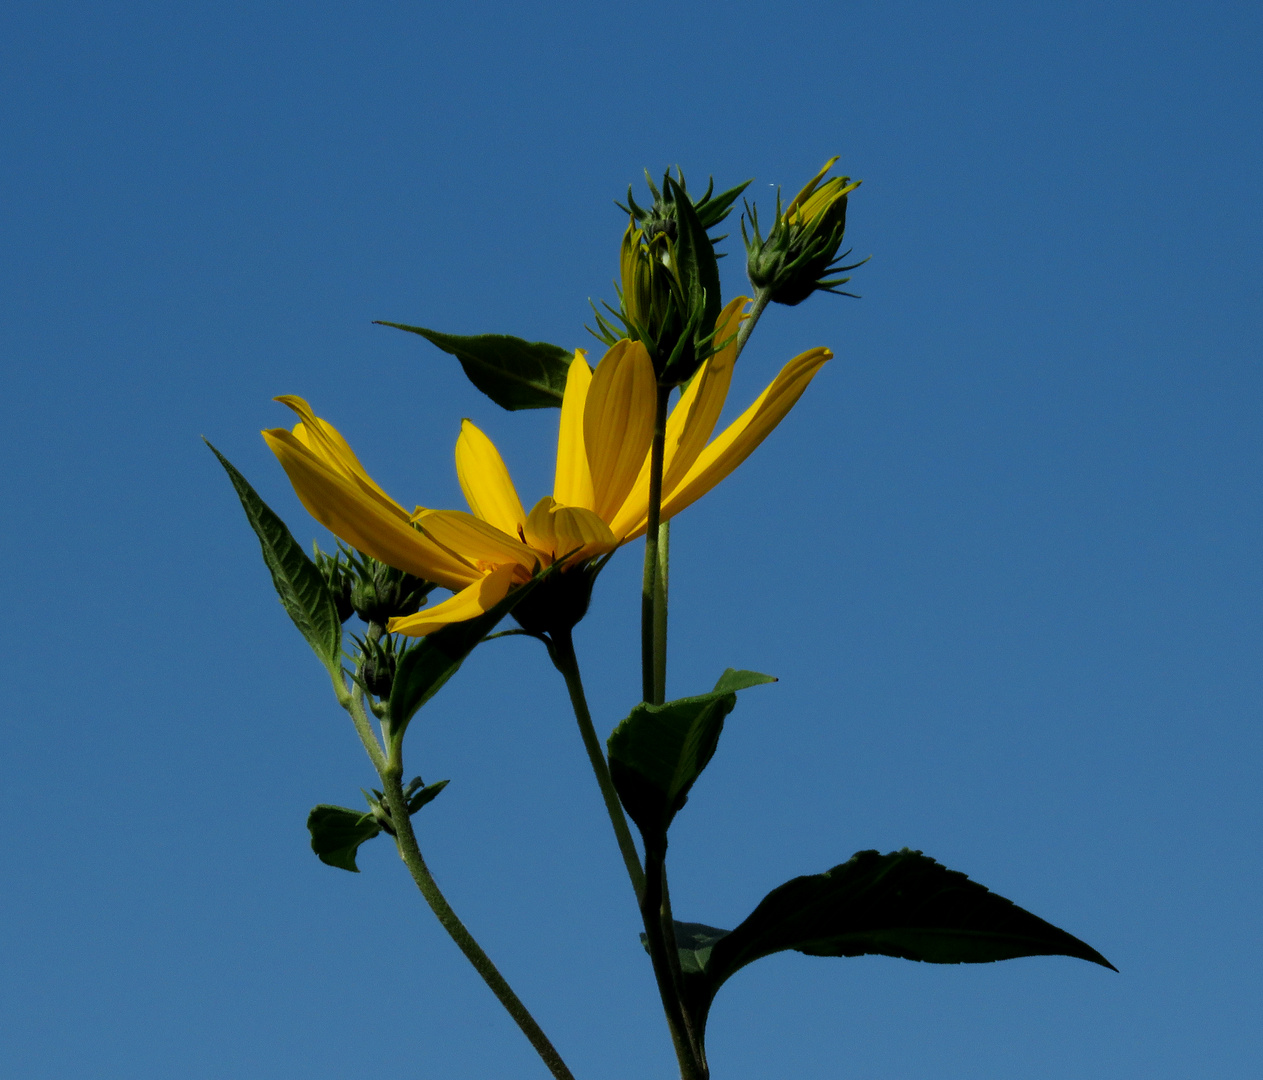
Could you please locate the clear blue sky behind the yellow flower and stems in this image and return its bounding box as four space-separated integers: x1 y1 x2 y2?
0 0 1263 1080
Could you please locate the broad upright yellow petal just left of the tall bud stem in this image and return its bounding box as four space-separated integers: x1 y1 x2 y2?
584 340 658 522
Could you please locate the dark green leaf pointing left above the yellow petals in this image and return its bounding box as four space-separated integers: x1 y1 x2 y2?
378 320 575 412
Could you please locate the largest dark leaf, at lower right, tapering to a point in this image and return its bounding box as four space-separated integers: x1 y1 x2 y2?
677 848 1116 1027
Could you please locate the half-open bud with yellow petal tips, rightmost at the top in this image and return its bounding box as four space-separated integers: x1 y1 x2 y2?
741 158 866 307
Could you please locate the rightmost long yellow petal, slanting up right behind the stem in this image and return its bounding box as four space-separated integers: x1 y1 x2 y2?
615 349 834 539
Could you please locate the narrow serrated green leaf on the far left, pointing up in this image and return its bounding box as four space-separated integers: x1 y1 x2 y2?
203 440 342 680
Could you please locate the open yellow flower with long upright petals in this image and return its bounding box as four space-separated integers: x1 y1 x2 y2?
263 297 832 637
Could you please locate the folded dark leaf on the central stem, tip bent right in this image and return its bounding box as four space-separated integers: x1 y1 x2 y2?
608 668 775 845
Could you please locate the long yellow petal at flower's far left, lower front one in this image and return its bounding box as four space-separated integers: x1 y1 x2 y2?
263 428 479 590
